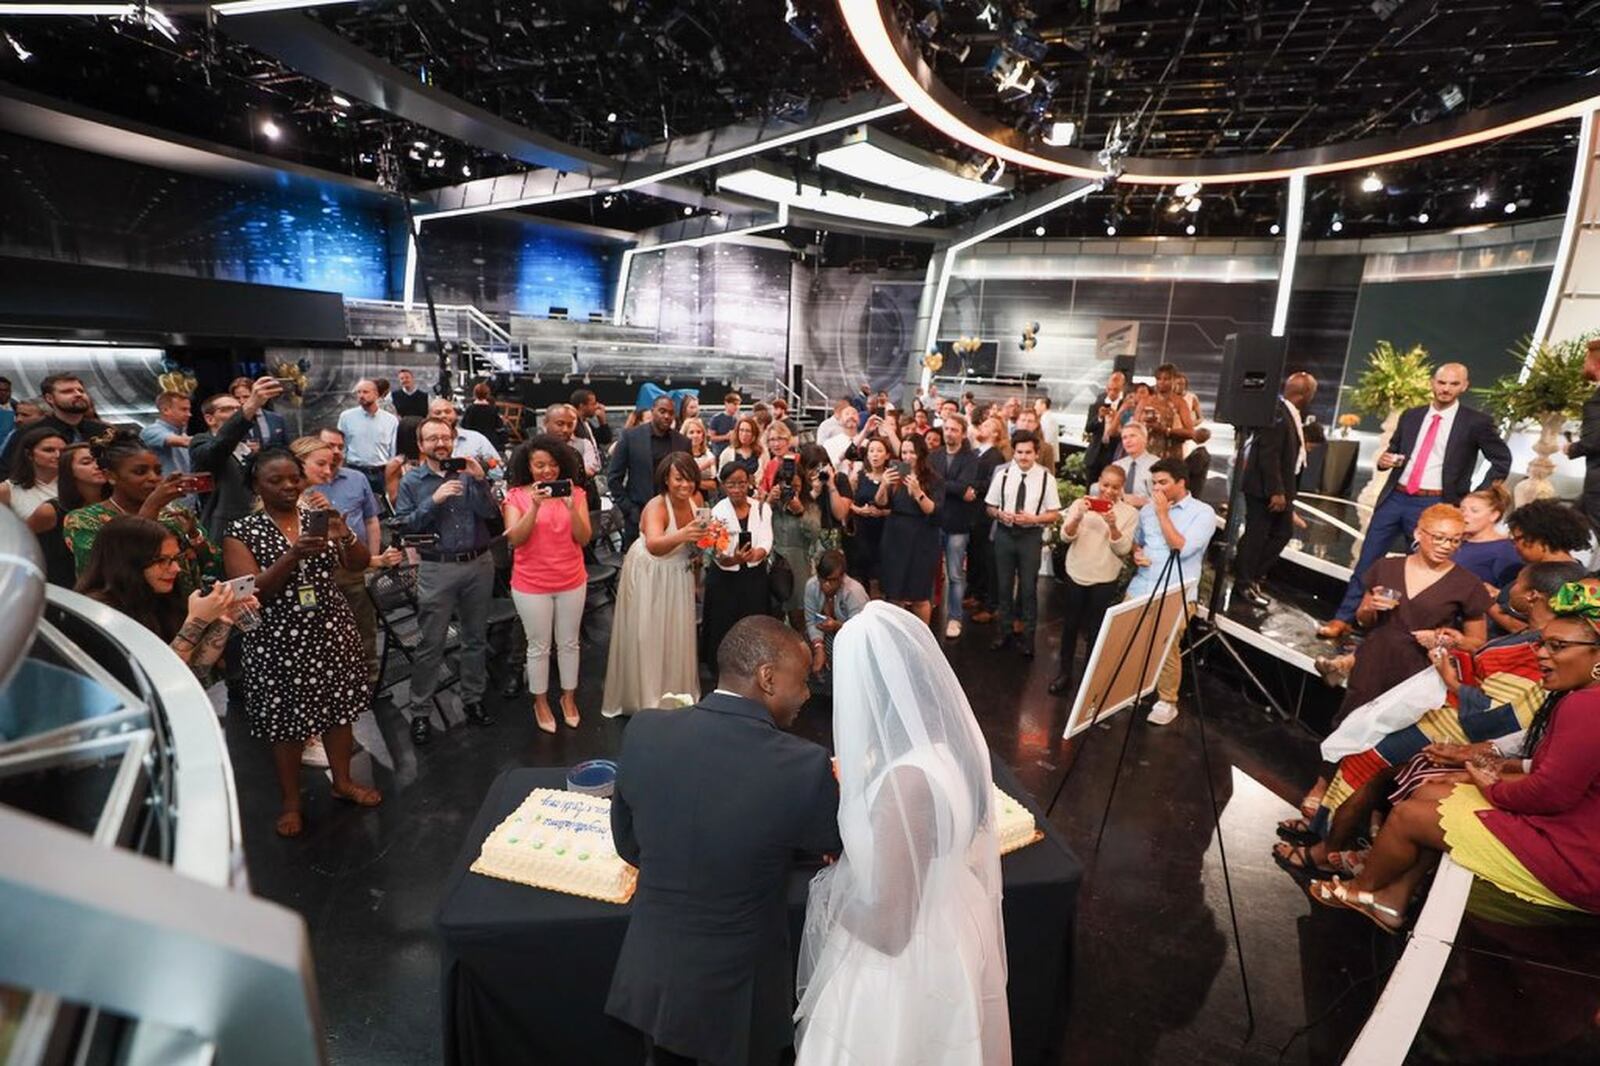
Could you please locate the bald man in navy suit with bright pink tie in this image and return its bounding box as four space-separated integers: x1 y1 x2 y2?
1317 363 1510 640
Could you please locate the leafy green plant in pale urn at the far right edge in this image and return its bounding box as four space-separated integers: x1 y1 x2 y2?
1486 331 1600 506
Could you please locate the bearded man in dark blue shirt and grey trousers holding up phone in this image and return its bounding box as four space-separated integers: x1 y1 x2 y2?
395 418 499 744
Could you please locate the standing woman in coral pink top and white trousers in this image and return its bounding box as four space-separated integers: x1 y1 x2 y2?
504 437 592 733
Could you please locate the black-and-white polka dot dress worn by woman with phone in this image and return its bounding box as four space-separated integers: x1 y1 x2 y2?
227 511 371 743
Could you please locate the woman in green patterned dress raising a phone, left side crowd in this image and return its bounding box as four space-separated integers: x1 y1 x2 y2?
61 429 222 595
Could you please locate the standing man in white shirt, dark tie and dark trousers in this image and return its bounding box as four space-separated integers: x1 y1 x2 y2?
984 432 1061 659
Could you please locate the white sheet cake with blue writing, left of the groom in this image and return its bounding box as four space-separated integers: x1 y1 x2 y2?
472 789 638 903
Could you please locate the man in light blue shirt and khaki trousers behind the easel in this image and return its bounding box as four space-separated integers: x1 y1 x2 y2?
1125 459 1216 725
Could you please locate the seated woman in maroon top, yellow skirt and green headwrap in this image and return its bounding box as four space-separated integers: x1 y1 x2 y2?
1309 578 1600 933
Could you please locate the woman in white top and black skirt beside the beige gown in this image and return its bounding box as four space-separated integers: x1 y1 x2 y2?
701 466 773 667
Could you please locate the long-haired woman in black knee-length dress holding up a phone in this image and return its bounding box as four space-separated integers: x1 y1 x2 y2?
872 434 944 624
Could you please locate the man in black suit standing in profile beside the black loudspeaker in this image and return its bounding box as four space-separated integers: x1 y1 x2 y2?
1234 373 1317 610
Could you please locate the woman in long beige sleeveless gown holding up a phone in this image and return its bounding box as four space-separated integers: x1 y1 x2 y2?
600 451 706 719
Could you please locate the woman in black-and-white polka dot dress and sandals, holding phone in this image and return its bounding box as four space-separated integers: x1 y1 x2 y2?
222 448 382 837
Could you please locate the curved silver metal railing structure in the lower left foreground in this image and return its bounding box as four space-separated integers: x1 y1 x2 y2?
0 509 325 1066
